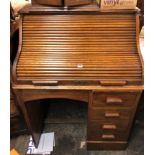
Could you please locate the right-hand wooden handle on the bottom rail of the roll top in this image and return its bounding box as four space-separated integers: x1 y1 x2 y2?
100 80 127 86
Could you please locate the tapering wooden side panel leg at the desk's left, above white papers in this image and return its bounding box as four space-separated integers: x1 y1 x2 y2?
14 90 46 147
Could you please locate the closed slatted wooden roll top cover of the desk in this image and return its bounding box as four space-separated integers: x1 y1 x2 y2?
16 14 142 84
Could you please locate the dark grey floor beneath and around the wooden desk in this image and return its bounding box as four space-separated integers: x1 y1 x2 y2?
10 100 144 155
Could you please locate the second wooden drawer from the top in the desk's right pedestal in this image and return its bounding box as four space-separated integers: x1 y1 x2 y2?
89 108 132 120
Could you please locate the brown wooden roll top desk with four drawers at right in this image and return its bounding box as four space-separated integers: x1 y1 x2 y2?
12 4 143 150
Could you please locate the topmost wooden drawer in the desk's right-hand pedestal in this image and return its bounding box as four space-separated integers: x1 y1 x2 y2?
92 92 138 107
